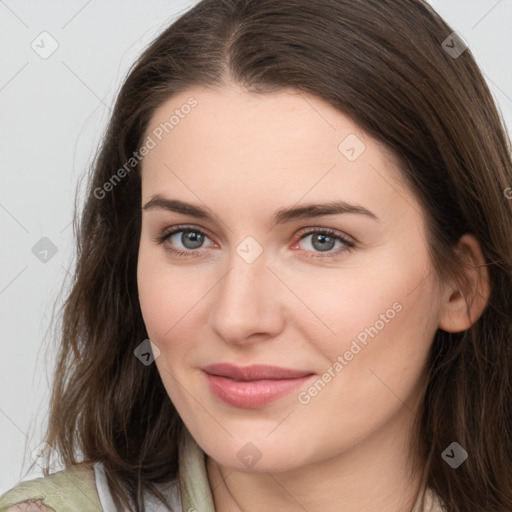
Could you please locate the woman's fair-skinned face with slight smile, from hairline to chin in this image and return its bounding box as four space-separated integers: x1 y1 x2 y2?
137 85 441 471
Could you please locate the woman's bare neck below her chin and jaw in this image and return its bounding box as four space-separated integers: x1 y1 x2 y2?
206 408 424 512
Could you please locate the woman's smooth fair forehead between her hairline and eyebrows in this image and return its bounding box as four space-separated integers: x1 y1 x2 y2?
142 85 414 219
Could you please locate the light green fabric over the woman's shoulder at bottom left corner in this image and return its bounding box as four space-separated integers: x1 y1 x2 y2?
0 464 103 512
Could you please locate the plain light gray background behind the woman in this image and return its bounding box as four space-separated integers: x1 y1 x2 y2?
0 0 512 494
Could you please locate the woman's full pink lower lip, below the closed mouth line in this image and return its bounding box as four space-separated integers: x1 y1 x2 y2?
205 372 314 409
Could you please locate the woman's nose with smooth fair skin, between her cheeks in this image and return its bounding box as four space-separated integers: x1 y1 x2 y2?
209 247 284 345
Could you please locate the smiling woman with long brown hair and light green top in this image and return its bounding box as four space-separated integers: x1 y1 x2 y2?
0 0 512 512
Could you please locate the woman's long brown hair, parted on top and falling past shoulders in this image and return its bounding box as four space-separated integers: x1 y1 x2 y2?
34 0 512 512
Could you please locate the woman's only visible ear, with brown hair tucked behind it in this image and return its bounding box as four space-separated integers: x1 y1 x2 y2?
439 234 491 332
